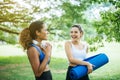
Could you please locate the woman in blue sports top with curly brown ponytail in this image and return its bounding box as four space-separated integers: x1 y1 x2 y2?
19 21 52 80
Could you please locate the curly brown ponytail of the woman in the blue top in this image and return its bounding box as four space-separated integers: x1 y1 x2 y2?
19 28 32 50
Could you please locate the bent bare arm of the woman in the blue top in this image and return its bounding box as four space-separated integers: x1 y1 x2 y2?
28 44 51 76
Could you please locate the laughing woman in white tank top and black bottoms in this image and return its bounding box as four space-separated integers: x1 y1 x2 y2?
65 25 93 80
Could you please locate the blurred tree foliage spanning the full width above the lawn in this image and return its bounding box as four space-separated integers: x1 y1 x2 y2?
0 0 120 50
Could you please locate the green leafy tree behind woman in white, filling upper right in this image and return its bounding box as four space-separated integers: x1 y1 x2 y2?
48 0 120 51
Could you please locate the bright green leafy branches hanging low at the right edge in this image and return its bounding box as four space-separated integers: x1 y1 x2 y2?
84 0 120 51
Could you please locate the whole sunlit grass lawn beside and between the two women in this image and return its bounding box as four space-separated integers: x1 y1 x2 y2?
0 42 120 80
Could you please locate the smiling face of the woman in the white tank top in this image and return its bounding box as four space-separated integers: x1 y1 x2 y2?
70 27 82 41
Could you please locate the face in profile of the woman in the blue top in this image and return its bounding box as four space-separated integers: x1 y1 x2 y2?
38 25 48 40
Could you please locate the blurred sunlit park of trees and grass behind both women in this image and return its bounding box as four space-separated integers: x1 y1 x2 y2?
0 0 120 80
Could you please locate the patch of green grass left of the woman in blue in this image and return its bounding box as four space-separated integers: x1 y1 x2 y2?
0 56 34 80
